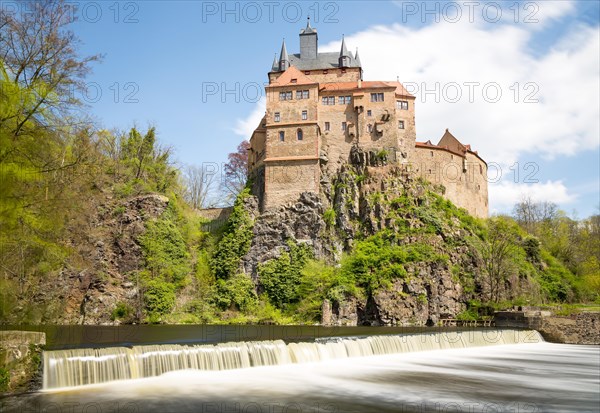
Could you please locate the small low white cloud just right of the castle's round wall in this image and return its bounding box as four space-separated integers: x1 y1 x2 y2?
489 181 577 213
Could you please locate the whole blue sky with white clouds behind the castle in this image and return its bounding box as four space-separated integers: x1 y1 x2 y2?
62 0 600 218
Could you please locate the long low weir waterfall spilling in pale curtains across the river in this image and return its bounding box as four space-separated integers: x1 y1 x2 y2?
43 329 543 390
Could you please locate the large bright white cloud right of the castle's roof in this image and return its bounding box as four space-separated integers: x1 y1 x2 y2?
320 17 600 165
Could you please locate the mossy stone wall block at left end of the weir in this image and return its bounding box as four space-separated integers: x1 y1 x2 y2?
0 330 46 393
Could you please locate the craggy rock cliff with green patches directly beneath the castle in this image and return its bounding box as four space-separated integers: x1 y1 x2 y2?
243 149 486 325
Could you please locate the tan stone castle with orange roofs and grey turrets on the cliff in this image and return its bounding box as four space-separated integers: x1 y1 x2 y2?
248 19 488 217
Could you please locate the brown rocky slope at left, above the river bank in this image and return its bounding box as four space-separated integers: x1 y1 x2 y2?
5 194 169 324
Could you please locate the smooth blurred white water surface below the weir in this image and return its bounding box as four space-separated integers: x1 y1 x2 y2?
0 343 600 413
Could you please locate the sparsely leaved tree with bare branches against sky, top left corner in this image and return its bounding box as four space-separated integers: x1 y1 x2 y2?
0 0 101 136
